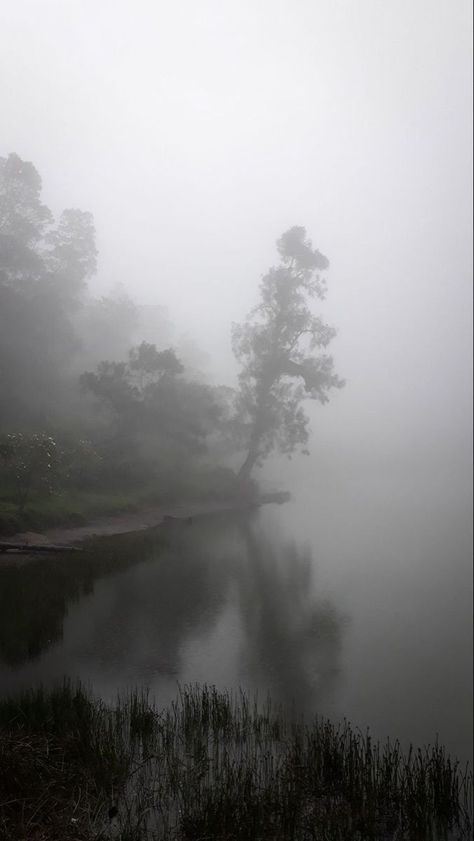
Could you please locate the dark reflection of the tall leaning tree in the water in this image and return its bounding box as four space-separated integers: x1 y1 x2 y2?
239 524 342 711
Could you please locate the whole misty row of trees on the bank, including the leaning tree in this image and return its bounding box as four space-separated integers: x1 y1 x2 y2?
0 154 343 531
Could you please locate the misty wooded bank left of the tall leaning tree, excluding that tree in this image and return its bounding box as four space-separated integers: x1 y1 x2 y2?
0 154 244 530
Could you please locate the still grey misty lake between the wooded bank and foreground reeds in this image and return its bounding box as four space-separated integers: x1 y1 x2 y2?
0 468 472 761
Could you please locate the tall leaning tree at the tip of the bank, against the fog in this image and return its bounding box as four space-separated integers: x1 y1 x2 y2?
232 227 344 479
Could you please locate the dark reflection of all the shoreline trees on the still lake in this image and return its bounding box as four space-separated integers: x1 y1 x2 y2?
0 514 342 711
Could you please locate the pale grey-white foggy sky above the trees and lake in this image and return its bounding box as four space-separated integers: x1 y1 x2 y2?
0 0 472 462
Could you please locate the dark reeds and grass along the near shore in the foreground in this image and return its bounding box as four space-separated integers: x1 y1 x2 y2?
0 683 472 841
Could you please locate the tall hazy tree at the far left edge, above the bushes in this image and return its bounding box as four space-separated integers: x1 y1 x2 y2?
0 154 97 429
